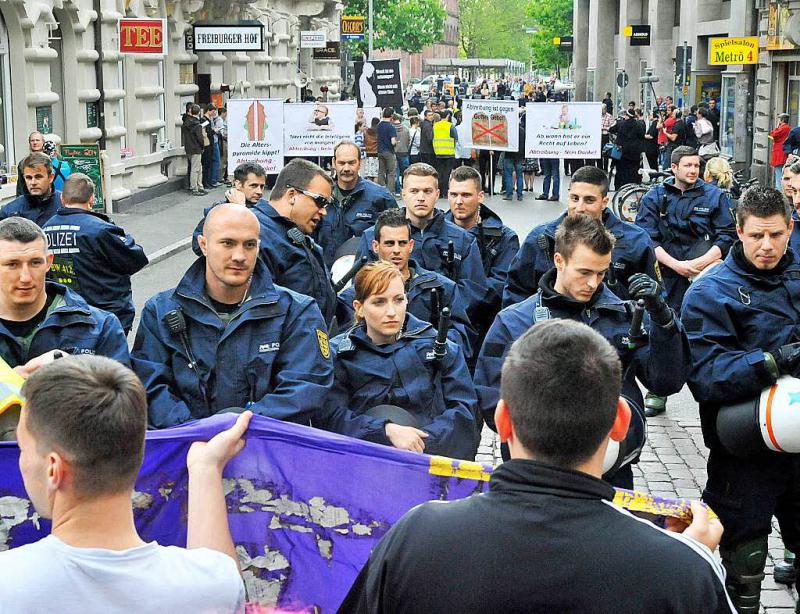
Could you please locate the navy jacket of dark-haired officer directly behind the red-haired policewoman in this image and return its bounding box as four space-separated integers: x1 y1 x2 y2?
336 260 477 361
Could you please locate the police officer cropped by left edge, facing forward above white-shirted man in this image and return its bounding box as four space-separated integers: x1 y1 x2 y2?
0 217 130 375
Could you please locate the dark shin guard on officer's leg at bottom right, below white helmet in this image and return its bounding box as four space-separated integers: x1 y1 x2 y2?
720 535 767 614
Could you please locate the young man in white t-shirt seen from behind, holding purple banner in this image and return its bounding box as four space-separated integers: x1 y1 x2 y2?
0 356 247 614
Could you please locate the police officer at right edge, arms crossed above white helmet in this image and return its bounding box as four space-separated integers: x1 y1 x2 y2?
682 185 800 613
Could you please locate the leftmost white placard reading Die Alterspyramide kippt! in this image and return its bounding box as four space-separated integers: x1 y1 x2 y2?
227 99 283 173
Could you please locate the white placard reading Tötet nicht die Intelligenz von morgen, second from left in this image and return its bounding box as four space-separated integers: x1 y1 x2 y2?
283 101 356 156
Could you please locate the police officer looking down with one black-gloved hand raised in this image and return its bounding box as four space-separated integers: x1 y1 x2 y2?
475 215 689 488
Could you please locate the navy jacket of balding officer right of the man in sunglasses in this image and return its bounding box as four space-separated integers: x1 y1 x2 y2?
318 178 397 267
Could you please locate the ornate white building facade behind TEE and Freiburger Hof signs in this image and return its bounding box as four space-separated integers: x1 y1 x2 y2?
0 0 343 204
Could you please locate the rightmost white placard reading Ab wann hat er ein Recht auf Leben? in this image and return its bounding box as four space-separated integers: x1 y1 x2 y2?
525 102 603 158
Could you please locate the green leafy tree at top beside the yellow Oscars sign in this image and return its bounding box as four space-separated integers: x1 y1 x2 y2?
344 0 447 54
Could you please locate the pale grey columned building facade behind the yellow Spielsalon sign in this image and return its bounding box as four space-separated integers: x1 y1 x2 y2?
573 0 756 173
